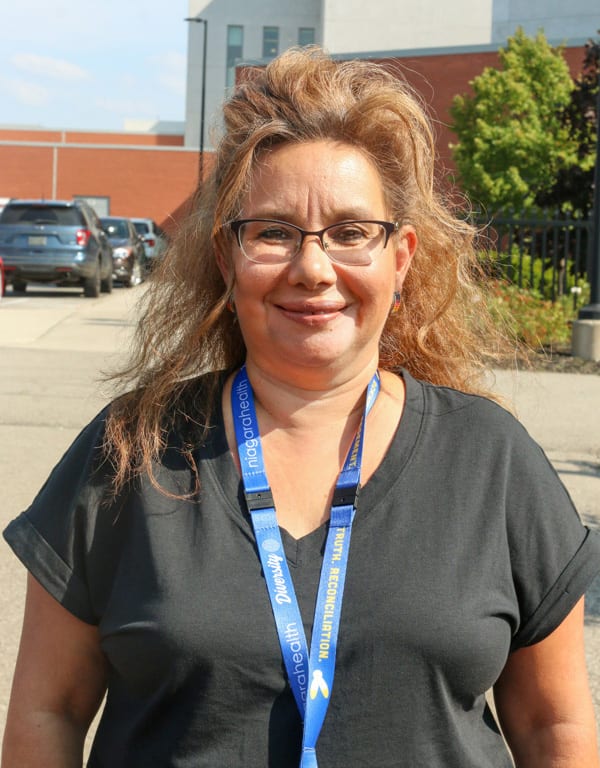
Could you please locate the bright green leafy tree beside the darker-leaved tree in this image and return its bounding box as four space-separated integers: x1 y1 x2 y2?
450 28 577 214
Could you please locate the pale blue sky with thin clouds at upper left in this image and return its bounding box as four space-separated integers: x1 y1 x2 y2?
0 0 188 131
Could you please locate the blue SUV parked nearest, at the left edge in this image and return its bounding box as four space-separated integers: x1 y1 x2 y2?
0 199 112 298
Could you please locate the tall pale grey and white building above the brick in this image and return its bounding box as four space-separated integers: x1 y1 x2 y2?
185 0 600 148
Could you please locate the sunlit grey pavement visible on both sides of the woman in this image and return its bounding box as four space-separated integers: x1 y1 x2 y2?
0 286 600 756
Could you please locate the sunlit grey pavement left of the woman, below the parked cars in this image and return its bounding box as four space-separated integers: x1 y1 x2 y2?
0 286 143 756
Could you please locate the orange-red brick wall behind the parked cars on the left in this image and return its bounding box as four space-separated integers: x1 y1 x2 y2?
0 130 199 229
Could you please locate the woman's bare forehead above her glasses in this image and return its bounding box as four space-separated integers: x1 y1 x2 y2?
242 140 386 219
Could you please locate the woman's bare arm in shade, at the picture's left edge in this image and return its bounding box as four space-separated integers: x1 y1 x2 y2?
2 576 106 768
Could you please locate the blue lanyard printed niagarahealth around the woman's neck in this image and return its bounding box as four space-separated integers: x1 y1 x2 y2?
231 366 380 768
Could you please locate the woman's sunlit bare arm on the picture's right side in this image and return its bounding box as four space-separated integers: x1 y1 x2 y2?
494 598 600 768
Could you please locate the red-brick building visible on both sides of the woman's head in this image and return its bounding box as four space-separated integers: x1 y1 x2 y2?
0 40 584 231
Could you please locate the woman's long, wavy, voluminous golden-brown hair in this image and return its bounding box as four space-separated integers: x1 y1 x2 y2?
106 48 510 488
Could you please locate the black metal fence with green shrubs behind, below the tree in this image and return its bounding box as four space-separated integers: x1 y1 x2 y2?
475 211 592 307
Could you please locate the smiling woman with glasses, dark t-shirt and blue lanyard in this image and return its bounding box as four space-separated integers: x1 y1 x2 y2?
3 51 600 768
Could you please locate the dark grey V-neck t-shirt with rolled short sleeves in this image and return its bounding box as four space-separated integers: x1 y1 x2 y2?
4 372 600 768
